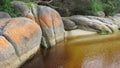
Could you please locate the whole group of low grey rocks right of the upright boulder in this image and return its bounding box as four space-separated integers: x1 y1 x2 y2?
62 15 120 34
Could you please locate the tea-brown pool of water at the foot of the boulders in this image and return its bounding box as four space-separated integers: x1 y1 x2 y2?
21 33 120 68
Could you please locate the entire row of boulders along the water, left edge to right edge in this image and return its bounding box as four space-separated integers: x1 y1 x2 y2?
0 1 120 68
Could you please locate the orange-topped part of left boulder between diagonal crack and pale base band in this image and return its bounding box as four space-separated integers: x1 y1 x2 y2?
3 18 42 56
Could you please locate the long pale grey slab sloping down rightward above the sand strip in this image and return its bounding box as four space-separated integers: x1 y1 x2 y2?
70 15 112 34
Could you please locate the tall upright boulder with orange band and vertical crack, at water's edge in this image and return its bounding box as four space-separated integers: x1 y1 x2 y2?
38 6 64 48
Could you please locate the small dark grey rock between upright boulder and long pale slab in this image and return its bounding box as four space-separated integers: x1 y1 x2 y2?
62 17 77 31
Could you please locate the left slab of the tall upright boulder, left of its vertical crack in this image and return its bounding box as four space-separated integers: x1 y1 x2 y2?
38 6 56 48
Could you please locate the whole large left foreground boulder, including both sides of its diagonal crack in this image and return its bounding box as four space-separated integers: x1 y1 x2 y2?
0 18 42 68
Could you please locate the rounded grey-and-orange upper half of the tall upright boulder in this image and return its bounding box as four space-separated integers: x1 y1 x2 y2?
39 6 61 27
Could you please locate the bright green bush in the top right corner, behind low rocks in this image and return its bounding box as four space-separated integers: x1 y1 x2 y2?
90 0 120 16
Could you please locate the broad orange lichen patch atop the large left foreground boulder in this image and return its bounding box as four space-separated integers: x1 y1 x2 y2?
5 18 39 44
